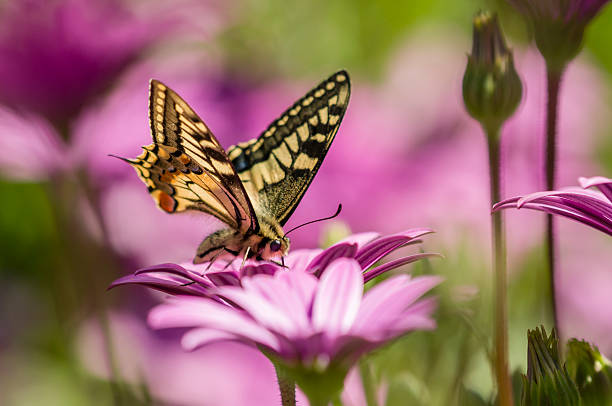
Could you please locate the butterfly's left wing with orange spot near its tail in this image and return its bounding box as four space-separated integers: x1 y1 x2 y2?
126 80 259 233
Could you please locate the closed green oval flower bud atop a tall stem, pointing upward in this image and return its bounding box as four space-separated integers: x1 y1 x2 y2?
463 12 523 132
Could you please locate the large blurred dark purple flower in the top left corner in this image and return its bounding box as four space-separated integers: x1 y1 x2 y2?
0 0 167 131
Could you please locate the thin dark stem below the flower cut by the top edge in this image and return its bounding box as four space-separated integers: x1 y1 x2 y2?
544 66 563 336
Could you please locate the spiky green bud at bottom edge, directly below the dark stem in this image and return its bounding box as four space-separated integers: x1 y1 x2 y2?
521 327 581 406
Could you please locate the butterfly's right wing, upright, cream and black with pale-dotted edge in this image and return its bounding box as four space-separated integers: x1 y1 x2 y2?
228 71 351 225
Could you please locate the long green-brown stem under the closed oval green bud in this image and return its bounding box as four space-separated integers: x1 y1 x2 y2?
485 127 512 406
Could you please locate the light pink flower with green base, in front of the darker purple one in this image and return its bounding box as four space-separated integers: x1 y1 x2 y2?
149 258 440 404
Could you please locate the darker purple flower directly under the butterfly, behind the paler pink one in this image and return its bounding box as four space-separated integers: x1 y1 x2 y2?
110 228 436 298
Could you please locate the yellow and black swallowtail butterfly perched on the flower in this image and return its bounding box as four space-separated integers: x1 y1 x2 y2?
121 71 350 264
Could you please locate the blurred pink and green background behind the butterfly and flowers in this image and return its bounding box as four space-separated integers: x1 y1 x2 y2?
0 0 612 406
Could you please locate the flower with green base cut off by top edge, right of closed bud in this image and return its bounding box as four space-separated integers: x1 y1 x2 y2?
508 0 608 72
